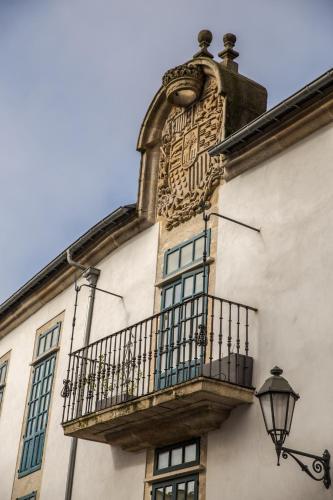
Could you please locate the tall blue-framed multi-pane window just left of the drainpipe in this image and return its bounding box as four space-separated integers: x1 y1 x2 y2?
19 323 60 477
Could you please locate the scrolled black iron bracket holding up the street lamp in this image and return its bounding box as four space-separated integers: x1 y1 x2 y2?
281 446 331 489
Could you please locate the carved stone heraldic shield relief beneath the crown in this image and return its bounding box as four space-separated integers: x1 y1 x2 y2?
157 77 223 229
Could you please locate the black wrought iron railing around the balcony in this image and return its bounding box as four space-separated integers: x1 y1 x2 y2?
62 294 256 423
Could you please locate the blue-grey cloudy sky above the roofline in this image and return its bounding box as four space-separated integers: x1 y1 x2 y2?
0 0 333 302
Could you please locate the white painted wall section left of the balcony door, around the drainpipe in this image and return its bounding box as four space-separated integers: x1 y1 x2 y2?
0 226 158 500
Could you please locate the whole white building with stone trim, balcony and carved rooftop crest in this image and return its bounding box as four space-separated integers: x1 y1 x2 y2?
0 30 333 500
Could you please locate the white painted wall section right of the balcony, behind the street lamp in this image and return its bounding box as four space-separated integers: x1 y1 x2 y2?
207 122 333 500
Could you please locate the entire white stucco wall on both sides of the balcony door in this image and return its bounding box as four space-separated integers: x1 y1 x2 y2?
0 119 333 500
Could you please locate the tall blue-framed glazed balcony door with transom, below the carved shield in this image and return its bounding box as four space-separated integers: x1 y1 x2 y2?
155 233 210 389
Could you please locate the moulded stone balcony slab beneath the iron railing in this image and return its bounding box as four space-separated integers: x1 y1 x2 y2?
63 376 254 451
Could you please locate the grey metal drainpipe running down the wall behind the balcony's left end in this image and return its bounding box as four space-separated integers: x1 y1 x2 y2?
65 251 101 500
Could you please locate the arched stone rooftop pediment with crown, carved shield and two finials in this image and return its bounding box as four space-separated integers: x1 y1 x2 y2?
137 34 267 230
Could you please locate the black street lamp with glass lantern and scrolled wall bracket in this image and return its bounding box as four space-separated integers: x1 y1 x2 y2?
256 366 331 488
